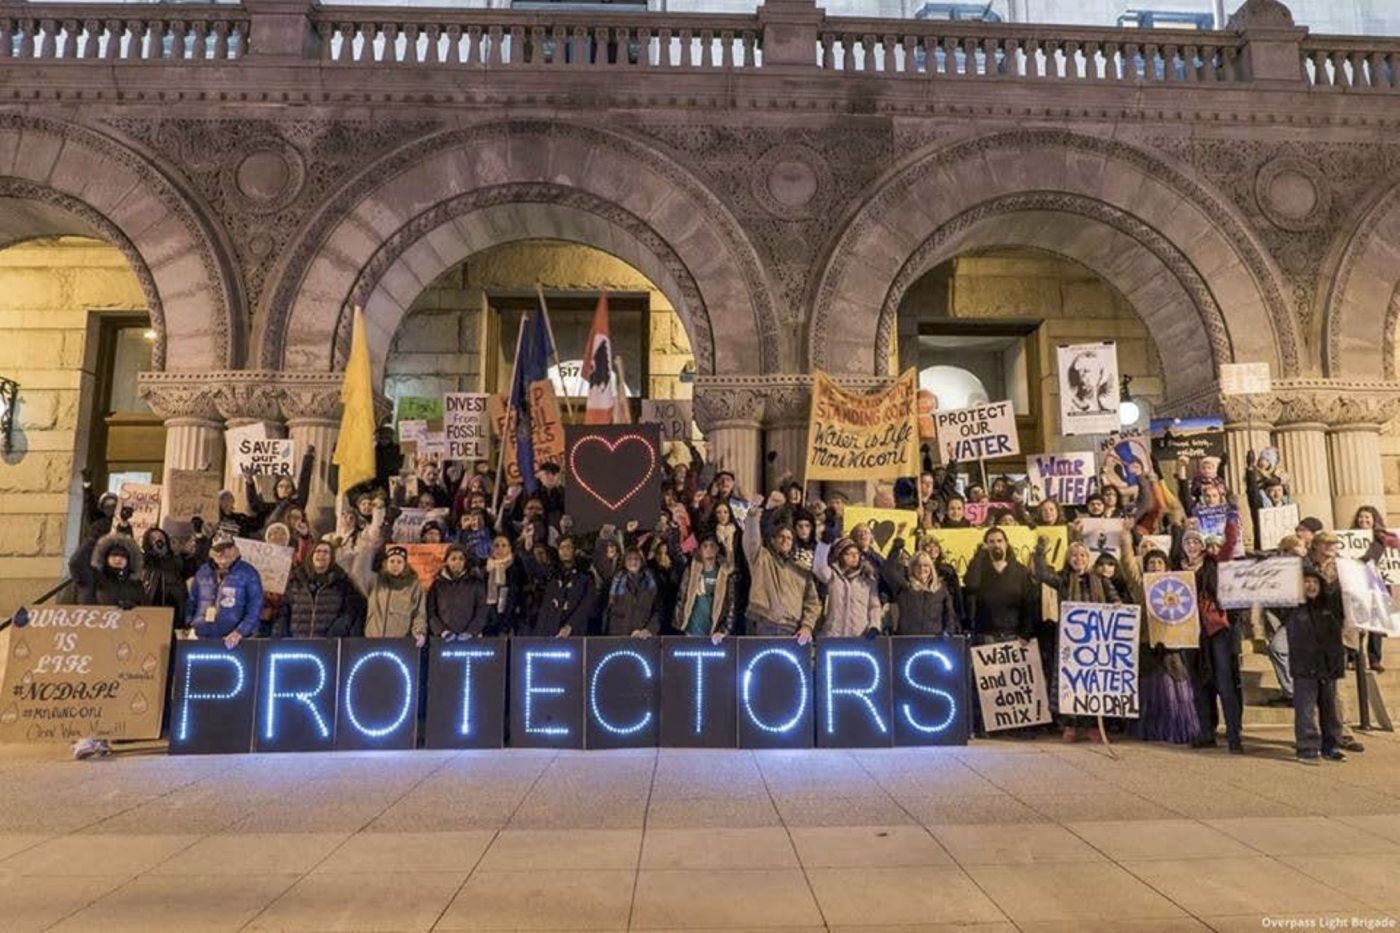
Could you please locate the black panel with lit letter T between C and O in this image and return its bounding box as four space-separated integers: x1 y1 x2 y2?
661 637 739 748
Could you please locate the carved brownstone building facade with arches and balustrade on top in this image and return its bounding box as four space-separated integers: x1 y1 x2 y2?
0 0 1400 599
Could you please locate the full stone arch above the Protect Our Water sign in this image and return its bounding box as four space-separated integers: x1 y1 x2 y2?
808 130 1301 396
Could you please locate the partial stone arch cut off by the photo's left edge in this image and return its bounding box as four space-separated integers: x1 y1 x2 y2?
0 113 244 370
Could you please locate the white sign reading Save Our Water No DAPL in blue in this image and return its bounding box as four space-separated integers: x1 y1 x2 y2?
1057 602 1141 719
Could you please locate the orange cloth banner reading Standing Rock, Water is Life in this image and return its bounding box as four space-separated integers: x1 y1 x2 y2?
806 368 920 481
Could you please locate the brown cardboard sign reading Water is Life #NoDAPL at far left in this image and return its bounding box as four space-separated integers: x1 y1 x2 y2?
0 605 174 742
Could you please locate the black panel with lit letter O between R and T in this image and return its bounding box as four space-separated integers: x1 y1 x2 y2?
336 639 423 749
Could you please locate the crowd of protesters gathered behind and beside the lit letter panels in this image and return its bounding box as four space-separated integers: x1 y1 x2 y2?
63 434 1400 762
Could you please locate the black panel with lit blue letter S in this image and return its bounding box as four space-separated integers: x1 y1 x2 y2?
890 637 969 745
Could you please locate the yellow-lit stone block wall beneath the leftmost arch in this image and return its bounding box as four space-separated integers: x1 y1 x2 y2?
0 237 146 616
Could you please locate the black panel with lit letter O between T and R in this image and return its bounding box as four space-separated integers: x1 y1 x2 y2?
735 639 813 748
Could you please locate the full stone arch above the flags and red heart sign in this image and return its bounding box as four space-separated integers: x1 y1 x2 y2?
255 120 778 373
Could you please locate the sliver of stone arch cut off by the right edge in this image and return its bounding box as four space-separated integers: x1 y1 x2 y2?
1322 176 1400 380
